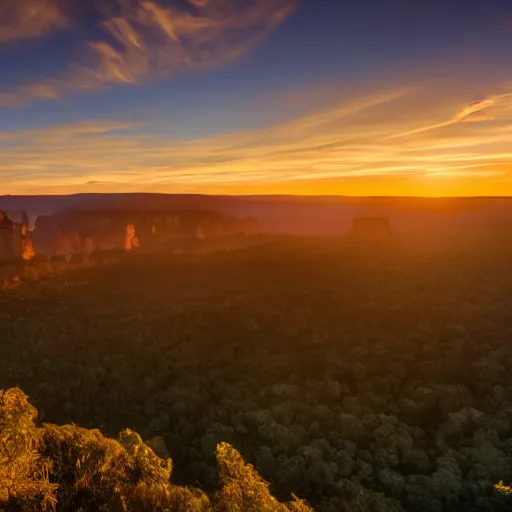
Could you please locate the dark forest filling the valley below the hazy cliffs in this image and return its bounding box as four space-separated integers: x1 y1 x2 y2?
0 232 512 512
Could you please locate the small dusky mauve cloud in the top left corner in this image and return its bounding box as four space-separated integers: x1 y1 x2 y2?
0 0 68 45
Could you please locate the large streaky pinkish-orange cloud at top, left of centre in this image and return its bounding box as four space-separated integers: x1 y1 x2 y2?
0 0 297 106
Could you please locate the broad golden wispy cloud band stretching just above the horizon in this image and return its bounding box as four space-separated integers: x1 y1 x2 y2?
4 81 512 193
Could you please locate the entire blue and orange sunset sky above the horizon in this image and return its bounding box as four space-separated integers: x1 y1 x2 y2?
0 0 512 196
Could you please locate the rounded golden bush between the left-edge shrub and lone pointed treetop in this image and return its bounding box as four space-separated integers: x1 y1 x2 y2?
41 425 178 510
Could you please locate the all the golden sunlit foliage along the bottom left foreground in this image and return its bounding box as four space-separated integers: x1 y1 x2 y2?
0 389 312 512
